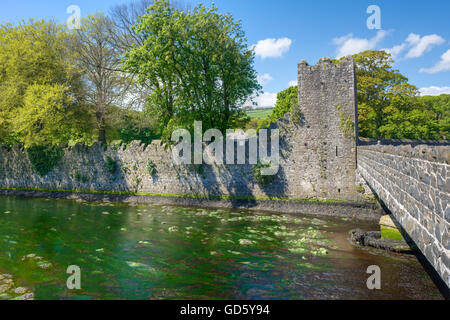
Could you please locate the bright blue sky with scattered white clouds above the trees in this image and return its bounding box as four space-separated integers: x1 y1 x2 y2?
0 0 450 107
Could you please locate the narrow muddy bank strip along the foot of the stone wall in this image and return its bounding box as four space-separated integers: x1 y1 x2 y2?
0 188 383 220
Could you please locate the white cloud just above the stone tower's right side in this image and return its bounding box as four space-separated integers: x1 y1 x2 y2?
333 30 389 58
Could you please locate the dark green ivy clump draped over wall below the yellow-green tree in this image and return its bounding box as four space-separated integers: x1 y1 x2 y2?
27 145 64 177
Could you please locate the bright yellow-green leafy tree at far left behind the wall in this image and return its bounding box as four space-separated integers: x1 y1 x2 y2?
0 20 88 146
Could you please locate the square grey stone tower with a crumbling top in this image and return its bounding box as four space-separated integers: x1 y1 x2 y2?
296 57 359 201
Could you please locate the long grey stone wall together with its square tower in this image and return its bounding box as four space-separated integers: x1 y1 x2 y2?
0 58 362 202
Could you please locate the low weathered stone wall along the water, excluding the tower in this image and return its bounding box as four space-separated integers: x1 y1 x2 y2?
0 141 282 197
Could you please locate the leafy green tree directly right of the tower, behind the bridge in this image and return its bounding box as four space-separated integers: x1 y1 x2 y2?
330 51 448 139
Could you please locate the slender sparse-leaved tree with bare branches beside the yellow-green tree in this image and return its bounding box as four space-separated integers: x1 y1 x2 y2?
71 14 132 144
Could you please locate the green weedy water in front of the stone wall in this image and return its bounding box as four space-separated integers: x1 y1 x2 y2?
0 197 442 300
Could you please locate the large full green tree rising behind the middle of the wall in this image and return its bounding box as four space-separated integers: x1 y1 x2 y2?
125 0 261 139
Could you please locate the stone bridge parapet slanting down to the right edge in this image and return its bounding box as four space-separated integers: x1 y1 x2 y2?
358 141 450 287
